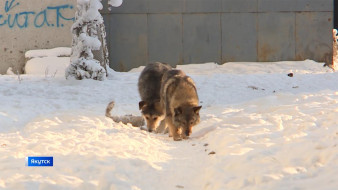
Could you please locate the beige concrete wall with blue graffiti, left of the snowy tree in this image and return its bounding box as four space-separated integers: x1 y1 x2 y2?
0 0 76 74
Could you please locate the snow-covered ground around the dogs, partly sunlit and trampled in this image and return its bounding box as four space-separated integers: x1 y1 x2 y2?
0 60 338 190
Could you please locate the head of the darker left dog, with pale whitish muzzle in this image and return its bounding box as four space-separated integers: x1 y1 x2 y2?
139 101 164 132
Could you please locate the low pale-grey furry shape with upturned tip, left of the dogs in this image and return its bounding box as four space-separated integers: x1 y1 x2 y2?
106 101 145 127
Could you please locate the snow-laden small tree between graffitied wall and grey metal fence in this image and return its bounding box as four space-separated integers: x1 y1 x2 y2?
66 0 121 80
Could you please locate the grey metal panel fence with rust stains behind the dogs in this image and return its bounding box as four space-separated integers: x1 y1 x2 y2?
102 0 333 71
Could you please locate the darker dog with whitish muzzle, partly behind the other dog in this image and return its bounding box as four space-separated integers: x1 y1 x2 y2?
138 62 172 132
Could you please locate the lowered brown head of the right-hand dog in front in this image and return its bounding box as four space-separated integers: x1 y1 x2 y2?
173 106 202 137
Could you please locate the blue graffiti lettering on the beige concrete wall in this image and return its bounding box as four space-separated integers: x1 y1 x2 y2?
0 0 75 29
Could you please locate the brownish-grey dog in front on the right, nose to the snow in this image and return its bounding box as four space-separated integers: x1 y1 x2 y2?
161 69 202 141
